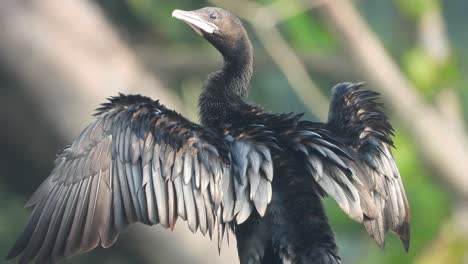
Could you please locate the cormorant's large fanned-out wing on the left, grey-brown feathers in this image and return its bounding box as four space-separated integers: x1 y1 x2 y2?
8 95 272 263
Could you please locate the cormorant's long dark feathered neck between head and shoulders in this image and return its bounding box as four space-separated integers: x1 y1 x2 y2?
199 39 253 127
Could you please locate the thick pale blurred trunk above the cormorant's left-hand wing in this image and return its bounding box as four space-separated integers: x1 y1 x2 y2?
0 0 182 135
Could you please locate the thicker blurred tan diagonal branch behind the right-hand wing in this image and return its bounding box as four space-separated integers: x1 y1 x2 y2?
318 0 468 199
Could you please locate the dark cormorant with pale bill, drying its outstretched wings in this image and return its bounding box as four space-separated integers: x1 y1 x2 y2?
7 7 409 263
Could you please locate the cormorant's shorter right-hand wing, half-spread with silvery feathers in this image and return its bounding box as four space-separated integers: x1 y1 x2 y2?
288 83 409 250
